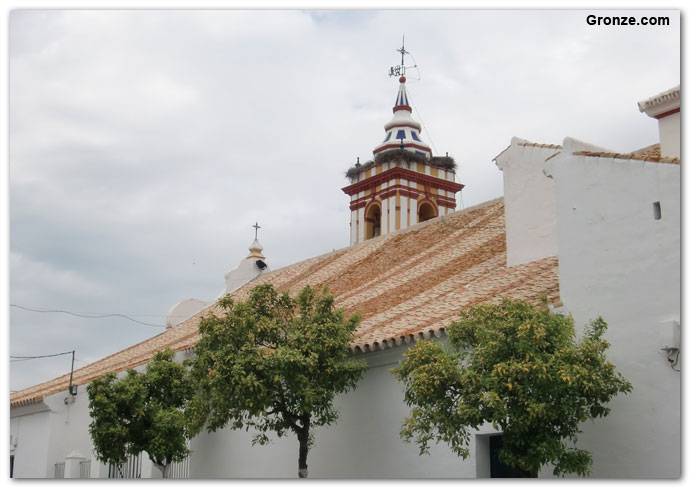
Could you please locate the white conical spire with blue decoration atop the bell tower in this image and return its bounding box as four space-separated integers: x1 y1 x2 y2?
374 76 431 159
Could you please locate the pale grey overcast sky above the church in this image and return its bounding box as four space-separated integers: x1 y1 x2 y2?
8 10 680 390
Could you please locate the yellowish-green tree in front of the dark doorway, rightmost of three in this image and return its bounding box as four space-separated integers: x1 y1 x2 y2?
393 300 632 476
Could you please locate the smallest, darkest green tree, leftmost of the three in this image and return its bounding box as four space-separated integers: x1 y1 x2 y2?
87 349 192 478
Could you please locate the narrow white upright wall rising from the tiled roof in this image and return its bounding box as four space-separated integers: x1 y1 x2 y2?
495 137 558 266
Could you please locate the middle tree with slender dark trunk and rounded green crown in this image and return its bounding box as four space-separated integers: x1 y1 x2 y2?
189 285 366 478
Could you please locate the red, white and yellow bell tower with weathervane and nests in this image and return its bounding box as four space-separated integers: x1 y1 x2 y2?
343 39 464 245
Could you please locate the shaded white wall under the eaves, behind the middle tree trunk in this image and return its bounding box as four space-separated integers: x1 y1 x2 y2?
185 347 476 478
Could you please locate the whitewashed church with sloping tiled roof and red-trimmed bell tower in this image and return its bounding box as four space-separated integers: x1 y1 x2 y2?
10 65 681 479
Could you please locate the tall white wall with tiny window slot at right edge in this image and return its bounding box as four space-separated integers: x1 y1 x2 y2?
547 139 681 478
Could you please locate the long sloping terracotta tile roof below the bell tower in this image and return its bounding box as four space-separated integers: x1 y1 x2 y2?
10 198 560 406
